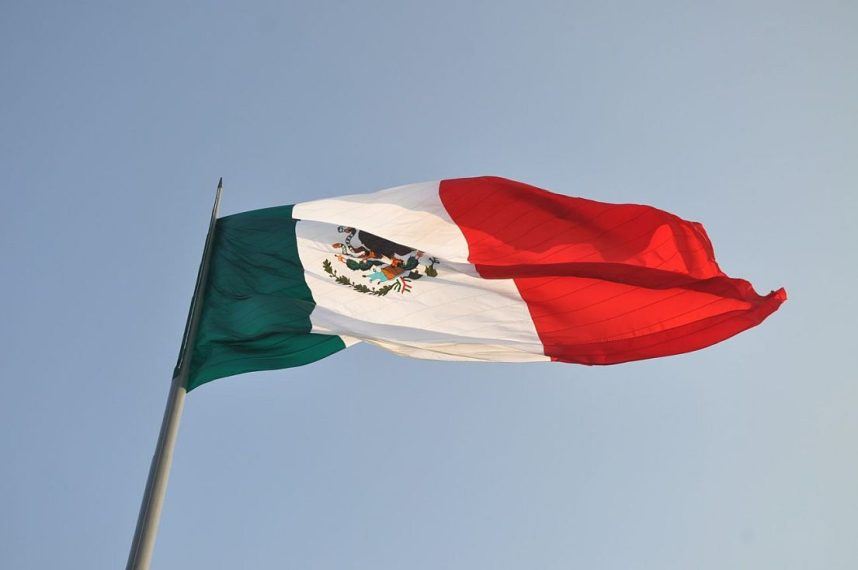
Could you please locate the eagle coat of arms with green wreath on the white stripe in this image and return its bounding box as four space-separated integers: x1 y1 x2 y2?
322 226 438 297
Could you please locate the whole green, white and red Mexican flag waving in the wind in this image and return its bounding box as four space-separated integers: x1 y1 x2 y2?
188 177 786 389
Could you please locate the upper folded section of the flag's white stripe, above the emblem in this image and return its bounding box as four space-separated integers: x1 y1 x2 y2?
292 182 468 264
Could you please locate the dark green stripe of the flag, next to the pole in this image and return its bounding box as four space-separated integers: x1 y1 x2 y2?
188 206 345 390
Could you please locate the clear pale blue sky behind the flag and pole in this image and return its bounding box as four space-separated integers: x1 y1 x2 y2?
0 0 858 570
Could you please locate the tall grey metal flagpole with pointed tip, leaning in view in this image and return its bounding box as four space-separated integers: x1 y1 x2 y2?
125 178 223 570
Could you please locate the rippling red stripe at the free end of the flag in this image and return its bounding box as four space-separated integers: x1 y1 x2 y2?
440 177 786 364
